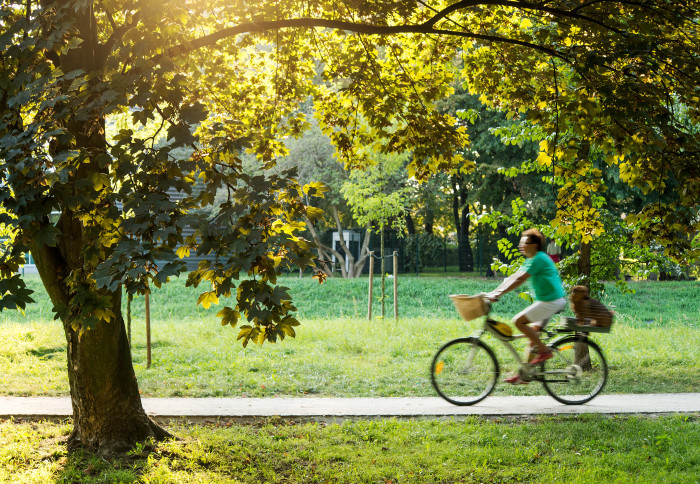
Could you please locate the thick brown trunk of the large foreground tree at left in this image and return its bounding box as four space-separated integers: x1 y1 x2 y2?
32 223 169 455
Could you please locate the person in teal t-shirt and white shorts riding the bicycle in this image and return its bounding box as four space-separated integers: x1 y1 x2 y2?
486 229 566 384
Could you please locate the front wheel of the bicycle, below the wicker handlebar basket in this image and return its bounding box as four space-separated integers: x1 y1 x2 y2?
430 338 500 405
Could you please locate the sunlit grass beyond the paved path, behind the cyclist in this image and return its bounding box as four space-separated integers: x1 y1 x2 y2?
0 277 700 397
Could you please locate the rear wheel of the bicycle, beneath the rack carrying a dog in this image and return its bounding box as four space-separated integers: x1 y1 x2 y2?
542 336 608 405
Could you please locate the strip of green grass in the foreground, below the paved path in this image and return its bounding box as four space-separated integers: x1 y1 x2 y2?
0 415 700 484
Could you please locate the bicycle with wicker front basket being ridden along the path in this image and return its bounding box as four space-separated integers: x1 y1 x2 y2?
430 294 610 405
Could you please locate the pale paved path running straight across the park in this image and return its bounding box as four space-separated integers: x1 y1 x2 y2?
0 393 700 420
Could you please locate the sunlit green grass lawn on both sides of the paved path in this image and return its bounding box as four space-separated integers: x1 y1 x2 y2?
0 276 700 484
